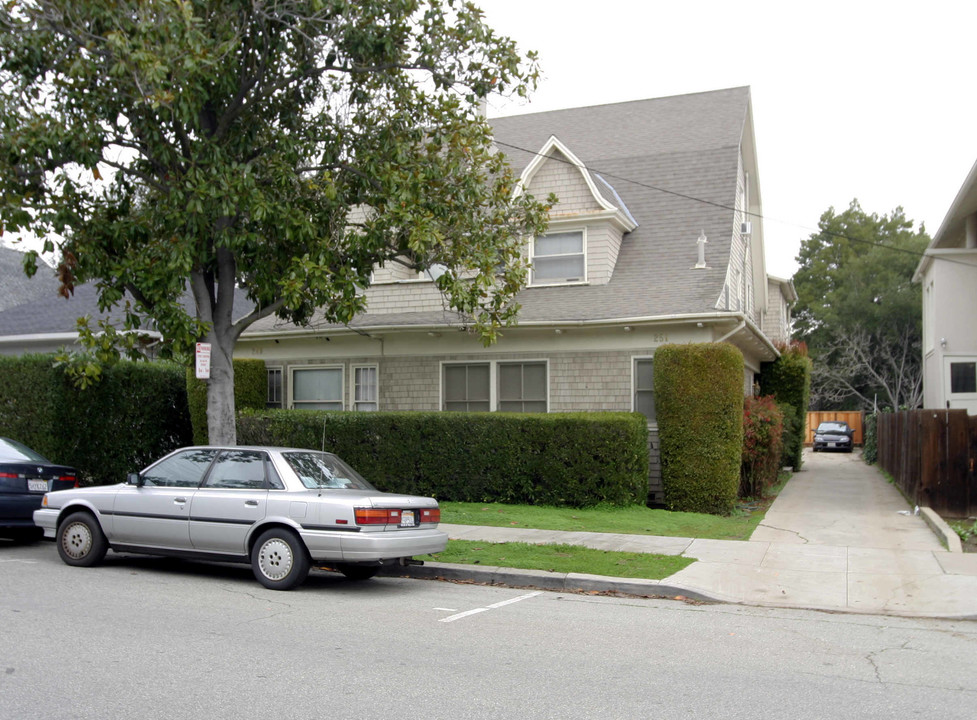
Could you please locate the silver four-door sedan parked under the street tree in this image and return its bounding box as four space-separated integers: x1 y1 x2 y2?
34 447 448 590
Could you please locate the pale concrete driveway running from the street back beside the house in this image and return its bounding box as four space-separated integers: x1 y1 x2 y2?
666 451 977 617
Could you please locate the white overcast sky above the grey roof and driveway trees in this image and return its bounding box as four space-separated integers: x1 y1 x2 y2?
475 0 977 277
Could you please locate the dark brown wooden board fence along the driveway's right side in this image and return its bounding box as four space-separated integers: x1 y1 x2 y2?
878 410 977 518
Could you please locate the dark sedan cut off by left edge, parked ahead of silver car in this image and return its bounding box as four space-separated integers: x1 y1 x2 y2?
0 437 78 539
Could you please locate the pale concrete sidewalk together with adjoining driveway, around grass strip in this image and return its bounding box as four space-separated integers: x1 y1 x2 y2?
388 453 977 619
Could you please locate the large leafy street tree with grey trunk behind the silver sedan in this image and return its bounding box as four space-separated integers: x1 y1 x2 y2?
0 0 548 443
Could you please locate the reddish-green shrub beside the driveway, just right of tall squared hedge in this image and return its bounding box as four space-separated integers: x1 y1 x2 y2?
740 395 784 497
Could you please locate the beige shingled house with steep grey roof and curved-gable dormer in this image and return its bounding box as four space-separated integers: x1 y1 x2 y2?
236 87 796 494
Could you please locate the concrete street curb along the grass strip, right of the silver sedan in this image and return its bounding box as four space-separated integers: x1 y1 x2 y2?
379 562 727 603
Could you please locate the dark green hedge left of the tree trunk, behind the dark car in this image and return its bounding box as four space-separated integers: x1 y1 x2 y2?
0 355 191 485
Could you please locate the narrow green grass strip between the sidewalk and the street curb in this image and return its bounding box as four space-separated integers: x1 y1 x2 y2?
421 540 694 580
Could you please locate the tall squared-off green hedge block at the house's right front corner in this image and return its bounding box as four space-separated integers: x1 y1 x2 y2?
655 343 744 515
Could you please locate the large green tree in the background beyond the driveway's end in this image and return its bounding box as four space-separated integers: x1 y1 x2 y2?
794 200 930 409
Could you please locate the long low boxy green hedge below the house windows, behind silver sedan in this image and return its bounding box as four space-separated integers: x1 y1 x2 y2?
237 410 648 507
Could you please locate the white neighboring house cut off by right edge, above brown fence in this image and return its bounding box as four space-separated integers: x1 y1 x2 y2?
913 164 977 415
